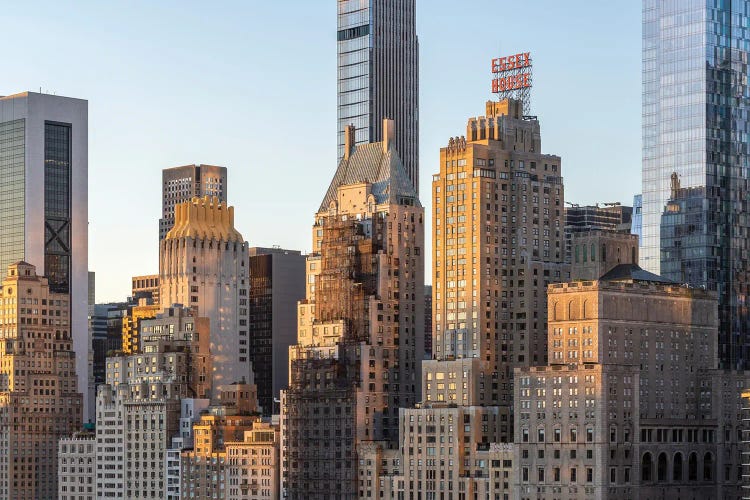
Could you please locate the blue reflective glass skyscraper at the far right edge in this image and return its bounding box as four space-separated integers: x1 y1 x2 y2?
640 0 750 368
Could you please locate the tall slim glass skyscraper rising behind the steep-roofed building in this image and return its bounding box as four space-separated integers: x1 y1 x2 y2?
337 0 419 189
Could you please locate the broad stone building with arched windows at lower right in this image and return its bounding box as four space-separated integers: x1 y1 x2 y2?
514 233 747 500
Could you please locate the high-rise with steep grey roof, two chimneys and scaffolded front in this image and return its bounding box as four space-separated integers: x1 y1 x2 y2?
282 120 424 498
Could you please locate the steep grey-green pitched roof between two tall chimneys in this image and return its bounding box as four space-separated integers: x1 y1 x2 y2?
320 142 422 212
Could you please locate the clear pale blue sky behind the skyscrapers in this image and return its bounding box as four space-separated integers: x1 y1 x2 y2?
0 0 641 302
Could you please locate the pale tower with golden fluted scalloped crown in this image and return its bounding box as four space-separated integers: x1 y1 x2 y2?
159 197 253 394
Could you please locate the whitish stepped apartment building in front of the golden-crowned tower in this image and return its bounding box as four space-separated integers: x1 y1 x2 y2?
96 307 211 498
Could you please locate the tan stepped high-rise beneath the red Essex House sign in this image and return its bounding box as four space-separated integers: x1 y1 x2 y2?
427 100 569 426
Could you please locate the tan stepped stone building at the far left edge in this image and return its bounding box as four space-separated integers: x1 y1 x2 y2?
0 262 86 499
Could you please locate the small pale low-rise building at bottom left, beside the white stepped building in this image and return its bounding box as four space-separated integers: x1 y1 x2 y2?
56 432 96 500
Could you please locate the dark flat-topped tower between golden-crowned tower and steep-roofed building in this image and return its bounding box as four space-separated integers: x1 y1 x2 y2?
247 247 305 416
